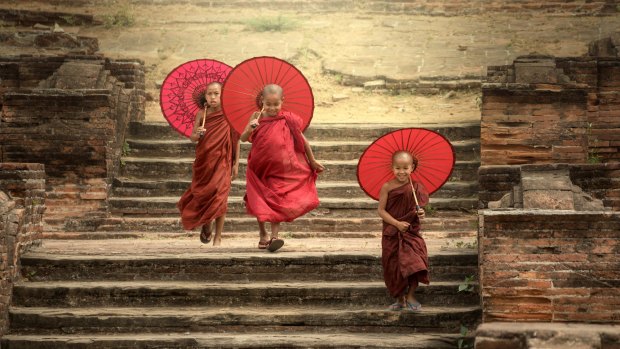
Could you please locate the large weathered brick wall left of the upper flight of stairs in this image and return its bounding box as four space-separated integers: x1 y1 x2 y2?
0 56 145 229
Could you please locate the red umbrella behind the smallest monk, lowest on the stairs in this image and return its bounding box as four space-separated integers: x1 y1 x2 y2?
357 128 455 200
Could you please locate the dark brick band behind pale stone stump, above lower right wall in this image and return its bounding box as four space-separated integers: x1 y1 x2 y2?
478 162 620 211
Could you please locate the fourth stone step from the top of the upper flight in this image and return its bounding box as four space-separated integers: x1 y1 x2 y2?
112 177 478 198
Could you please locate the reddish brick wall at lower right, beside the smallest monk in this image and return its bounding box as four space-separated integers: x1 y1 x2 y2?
478 210 620 323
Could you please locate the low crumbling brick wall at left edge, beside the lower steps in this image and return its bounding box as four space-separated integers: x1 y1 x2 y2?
0 163 45 337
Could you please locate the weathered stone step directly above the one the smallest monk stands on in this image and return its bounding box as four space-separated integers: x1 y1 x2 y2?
12 280 480 307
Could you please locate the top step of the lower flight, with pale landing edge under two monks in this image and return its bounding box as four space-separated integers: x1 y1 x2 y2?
21 241 478 282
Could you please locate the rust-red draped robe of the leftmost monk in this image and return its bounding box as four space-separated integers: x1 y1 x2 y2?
177 111 239 230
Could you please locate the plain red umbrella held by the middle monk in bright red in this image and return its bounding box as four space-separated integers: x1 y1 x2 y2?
222 57 314 133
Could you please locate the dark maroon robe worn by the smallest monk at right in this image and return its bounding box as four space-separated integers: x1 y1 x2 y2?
381 183 429 298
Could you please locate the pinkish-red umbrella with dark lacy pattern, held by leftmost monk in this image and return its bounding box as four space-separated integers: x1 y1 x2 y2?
159 59 232 137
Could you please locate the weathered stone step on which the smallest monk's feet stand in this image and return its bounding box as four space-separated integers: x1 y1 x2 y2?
10 305 480 335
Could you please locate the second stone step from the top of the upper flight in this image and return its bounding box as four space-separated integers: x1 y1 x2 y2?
126 139 480 161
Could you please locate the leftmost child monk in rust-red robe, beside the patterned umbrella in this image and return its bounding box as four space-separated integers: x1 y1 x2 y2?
177 82 239 246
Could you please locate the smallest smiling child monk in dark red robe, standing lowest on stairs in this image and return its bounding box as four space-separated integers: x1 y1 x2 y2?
378 151 429 311
